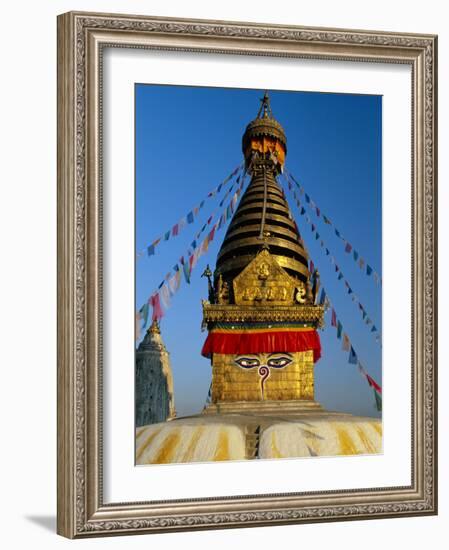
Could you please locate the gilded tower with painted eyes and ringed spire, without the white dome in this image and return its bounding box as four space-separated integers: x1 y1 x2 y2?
202 94 324 412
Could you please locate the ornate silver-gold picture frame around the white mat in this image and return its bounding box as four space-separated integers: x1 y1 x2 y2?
57 12 437 538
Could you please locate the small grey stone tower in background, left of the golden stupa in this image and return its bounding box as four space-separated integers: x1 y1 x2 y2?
135 321 176 427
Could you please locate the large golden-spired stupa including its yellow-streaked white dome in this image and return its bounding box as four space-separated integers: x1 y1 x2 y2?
136 93 382 464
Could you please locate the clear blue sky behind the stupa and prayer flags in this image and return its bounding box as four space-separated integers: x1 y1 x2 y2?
135 84 382 416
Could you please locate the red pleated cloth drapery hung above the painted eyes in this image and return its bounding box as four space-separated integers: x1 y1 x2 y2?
201 329 321 363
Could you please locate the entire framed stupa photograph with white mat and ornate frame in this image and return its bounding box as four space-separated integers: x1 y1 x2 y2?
58 12 437 538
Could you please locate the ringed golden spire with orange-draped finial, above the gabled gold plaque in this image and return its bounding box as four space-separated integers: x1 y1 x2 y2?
215 92 309 296
